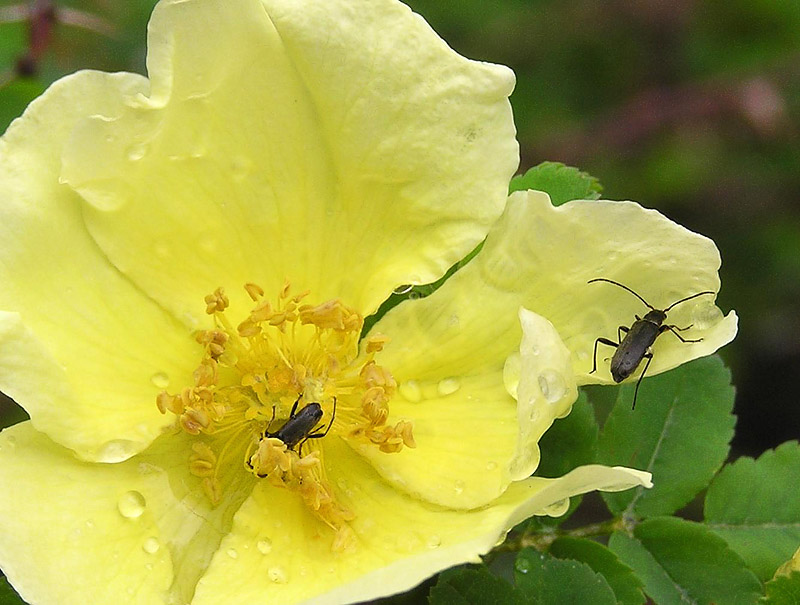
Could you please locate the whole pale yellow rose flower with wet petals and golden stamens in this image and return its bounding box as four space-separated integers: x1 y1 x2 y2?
0 0 736 605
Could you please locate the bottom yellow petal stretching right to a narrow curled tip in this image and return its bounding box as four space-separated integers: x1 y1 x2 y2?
193 443 649 605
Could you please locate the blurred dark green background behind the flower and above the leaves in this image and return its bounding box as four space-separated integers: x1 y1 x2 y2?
0 0 800 455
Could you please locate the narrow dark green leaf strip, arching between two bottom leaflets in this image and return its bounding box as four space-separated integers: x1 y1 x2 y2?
549 537 645 605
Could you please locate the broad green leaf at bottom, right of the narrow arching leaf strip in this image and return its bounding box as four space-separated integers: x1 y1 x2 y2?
608 517 761 605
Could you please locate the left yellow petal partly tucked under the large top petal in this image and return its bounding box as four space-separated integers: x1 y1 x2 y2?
0 72 197 461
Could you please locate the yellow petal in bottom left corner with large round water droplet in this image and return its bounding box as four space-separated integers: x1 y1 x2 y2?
0 422 249 605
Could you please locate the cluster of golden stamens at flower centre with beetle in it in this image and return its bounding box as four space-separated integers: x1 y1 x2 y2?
156 282 415 550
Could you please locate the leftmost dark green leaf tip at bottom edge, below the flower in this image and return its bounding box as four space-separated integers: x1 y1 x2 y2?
428 567 526 605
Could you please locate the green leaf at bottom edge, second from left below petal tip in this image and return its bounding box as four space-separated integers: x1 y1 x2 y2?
512 548 617 605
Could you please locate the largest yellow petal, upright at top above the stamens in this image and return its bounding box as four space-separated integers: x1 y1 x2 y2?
63 0 517 319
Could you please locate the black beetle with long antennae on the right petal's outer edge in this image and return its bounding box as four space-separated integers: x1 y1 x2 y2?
587 277 715 409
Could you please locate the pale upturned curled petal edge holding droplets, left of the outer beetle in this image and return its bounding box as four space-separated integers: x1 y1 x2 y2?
511 309 578 480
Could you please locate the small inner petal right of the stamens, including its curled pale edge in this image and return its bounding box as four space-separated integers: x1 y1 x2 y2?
353 309 577 508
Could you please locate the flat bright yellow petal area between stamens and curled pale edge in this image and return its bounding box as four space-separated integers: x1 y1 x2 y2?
352 370 520 508
